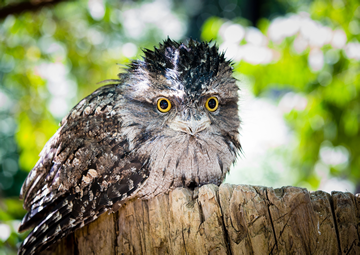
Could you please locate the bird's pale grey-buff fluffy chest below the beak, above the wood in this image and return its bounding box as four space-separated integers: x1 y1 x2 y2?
128 137 228 199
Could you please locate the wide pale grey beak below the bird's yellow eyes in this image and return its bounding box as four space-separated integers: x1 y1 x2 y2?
169 117 211 135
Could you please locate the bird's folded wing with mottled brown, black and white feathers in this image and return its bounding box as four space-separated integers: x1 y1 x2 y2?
19 85 148 255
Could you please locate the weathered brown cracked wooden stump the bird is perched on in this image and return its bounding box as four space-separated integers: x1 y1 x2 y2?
43 184 360 255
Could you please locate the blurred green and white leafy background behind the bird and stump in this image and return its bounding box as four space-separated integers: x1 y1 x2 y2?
0 0 360 252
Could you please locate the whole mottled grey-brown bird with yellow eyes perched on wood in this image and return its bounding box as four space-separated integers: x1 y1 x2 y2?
18 38 242 255
